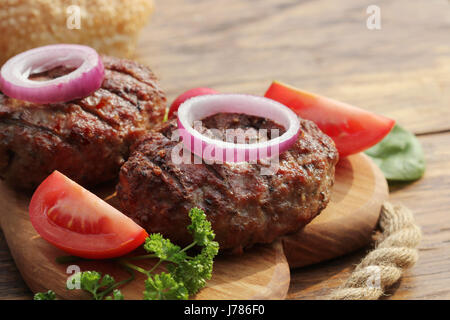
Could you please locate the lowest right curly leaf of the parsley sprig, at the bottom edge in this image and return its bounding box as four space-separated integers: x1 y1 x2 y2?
144 272 189 300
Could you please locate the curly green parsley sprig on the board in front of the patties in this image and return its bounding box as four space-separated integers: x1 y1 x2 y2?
34 208 219 300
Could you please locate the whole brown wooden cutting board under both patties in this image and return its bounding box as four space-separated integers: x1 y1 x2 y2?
0 154 388 299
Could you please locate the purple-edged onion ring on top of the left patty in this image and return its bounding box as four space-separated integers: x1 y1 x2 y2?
0 44 104 104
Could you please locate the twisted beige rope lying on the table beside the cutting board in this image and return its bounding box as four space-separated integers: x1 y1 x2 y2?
327 202 422 300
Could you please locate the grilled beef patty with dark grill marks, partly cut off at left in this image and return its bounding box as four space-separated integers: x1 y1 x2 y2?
0 56 166 189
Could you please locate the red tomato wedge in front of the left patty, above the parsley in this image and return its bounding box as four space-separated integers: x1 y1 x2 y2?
29 171 148 259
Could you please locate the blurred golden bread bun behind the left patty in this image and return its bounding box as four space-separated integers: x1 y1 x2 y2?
0 0 153 65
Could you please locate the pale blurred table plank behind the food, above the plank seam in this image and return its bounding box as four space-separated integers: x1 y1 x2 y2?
137 0 450 133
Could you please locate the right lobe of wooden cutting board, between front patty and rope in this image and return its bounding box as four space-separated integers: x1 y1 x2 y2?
282 154 388 268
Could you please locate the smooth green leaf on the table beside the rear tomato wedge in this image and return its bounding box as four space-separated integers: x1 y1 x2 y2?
365 124 425 181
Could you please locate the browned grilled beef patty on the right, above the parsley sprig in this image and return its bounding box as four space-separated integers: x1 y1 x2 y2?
117 114 338 252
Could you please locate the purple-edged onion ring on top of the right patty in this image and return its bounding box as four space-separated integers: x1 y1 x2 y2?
178 94 300 162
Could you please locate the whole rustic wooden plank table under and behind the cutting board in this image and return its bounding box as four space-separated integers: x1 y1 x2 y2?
0 0 450 299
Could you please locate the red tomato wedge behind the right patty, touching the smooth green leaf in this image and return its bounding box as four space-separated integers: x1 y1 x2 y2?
265 81 395 157
